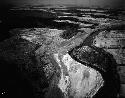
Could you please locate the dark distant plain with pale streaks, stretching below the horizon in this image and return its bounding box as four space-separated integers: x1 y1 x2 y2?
0 7 125 40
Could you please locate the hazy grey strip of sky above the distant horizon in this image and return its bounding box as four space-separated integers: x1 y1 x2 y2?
0 0 125 8
